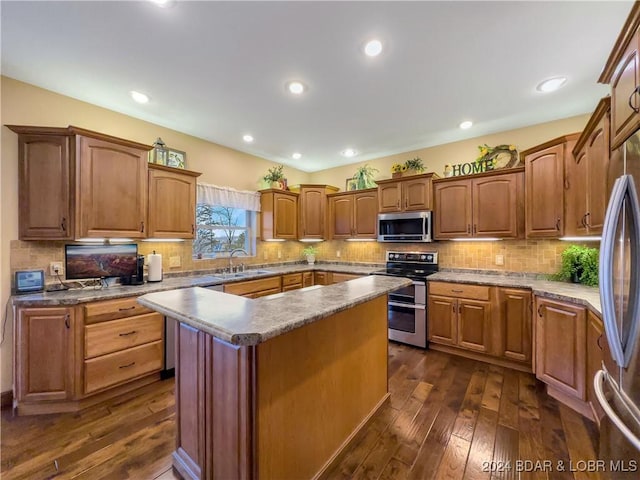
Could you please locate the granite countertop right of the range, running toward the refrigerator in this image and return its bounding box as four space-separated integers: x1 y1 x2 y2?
428 271 602 316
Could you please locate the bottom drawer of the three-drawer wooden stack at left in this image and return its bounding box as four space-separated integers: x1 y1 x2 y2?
84 341 163 393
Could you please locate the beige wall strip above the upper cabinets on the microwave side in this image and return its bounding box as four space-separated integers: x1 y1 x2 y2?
311 115 595 189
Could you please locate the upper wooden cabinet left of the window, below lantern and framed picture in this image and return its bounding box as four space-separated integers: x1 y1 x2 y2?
148 164 201 239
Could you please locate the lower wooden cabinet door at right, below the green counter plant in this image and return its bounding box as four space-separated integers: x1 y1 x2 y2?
536 297 586 400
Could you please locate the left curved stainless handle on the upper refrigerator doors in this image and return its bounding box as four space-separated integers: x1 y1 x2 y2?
599 176 628 367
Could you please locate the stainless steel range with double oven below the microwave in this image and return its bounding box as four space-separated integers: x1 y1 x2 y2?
372 251 438 348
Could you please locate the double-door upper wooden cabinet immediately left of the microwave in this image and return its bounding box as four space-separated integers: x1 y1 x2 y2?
328 188 378 239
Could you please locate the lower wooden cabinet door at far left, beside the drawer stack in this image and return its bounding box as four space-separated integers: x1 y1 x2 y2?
15 308 75 402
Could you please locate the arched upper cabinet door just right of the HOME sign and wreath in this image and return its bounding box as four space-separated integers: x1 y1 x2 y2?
524 143 565 237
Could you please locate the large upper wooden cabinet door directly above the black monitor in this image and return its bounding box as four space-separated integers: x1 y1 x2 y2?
76 136 147 238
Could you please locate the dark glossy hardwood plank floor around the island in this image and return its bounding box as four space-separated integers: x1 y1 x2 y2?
0 343 599 480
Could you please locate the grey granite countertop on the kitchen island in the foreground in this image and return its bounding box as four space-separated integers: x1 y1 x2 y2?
138 275 411 345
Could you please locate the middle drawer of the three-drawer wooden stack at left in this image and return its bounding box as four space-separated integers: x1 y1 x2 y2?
84 313 164 358
